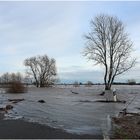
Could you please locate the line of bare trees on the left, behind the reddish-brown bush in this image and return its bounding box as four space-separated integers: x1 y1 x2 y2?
0 55 58 87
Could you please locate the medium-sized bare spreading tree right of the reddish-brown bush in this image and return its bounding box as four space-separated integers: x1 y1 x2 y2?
24 55 56 87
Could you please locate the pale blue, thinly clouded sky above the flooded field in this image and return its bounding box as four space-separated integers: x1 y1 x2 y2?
0 1 140 83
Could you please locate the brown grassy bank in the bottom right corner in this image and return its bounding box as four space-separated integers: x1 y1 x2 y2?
112 113 140 139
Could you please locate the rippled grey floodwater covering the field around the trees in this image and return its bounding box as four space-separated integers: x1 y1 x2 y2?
0 85 140 134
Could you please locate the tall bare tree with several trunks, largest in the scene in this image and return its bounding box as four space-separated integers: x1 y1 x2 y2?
84 14 136 90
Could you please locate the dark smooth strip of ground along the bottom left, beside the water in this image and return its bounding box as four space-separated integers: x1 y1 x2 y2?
0 120 102 139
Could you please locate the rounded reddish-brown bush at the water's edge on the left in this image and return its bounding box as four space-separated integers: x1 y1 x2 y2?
7 81 27 93
